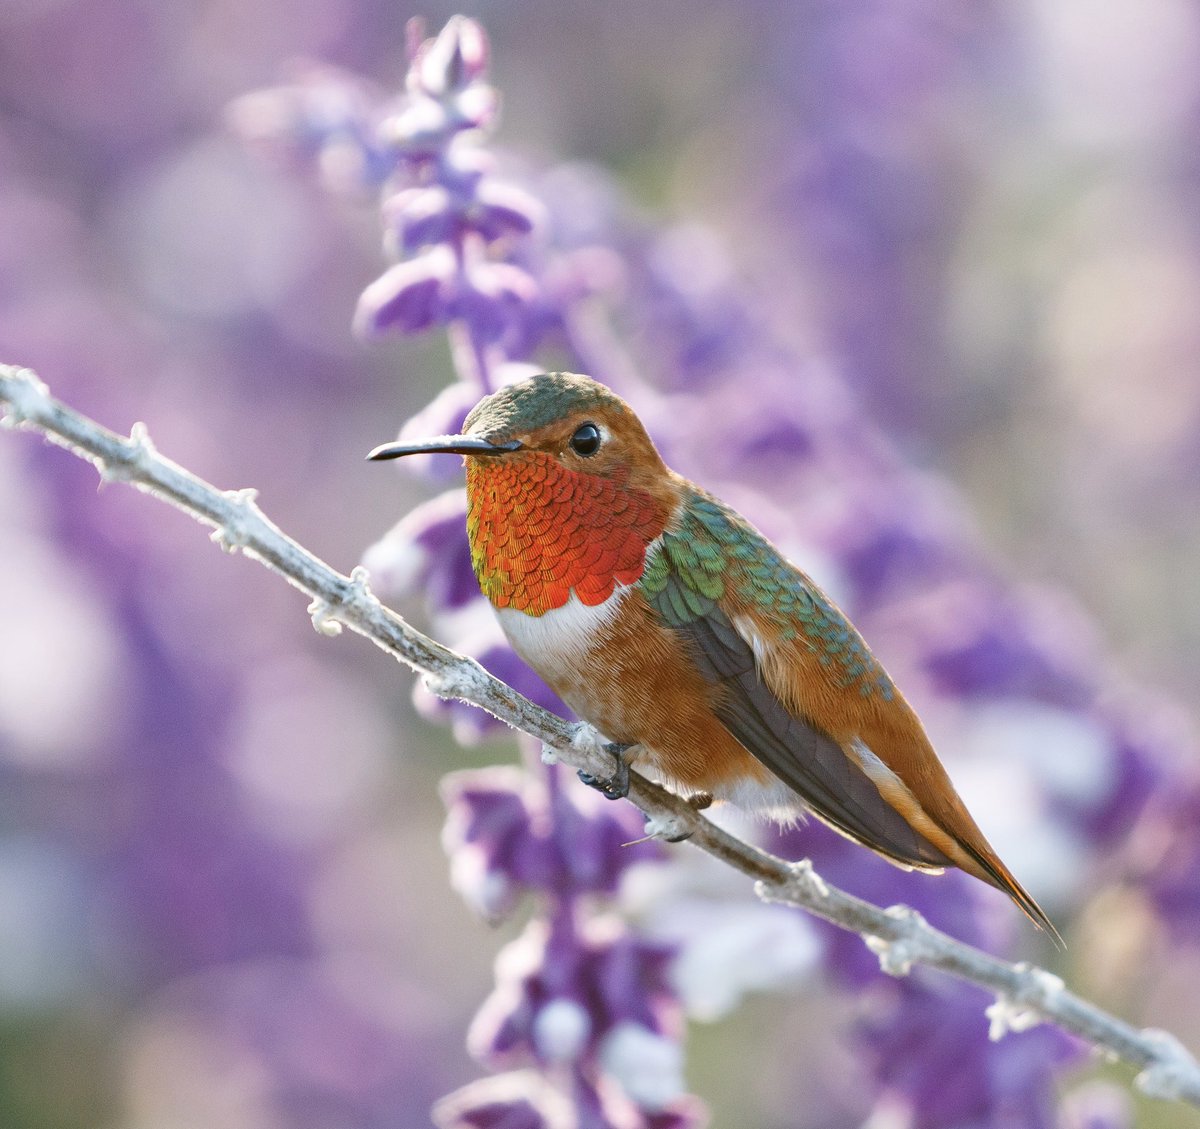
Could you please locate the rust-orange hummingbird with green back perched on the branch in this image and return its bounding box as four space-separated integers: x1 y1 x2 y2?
367 372 1061 944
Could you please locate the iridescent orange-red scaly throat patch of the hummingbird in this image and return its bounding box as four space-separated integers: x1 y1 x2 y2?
467 451 672 615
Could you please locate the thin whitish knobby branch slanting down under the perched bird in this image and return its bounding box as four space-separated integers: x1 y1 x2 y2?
0 366 1200 1106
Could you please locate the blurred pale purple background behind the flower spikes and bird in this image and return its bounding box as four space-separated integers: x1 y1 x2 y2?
0 0 1200 1129
